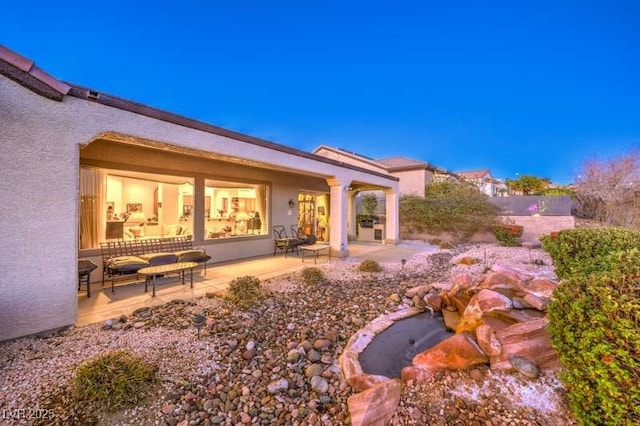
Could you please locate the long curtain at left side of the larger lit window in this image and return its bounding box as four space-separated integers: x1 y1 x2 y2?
79 167 107 249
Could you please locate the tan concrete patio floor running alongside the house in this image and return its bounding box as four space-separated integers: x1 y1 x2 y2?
75 241 437 326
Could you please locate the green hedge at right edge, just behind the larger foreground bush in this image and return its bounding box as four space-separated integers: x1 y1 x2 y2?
540 227 640 278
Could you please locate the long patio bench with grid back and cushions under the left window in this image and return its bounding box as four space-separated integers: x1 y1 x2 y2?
100 237 211 292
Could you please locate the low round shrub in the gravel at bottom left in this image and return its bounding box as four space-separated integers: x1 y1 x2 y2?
73 350 156 412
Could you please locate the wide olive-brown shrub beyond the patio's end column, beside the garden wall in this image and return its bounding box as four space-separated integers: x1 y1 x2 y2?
400 182 497 241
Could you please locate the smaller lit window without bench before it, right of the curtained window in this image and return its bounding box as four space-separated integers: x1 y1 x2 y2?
204 179 269 239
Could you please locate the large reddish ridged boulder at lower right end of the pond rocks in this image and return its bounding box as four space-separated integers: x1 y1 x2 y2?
491 318 560 370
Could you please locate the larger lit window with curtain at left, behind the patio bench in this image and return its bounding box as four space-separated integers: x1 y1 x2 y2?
79 167 194 249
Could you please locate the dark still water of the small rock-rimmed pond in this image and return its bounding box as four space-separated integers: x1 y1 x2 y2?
359 312 453 378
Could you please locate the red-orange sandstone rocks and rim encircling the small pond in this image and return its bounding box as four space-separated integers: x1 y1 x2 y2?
338 264 559 425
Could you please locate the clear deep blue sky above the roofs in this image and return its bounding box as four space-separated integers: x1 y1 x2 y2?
0 0 640 183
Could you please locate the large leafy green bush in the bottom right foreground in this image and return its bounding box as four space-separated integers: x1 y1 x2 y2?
548 255 640 425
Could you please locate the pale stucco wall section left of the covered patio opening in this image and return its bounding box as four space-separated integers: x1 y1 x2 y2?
0 77 78 340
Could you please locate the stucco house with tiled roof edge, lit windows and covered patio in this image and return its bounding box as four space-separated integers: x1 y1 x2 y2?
0 46 400 340
